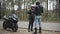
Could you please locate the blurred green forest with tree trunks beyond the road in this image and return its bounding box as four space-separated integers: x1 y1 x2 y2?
0 0 60 22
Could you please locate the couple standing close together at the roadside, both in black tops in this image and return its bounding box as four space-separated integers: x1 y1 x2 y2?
28 2 43 33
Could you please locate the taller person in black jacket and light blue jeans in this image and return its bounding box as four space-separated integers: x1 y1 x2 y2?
35 2 43 34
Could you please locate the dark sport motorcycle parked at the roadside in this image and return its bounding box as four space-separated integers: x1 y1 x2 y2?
3 16 18 32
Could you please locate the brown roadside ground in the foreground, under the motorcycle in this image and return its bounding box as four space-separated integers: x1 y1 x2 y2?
0 21 60 34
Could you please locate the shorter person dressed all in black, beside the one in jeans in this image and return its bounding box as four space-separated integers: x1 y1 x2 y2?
28 5 35 32
